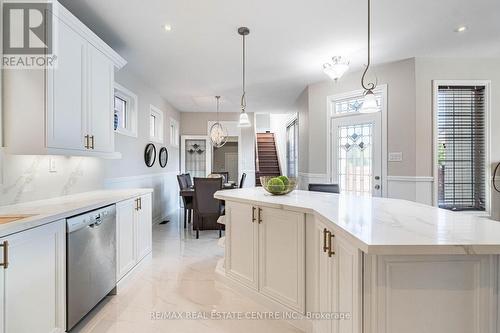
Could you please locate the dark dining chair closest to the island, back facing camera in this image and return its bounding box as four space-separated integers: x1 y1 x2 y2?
193 177 224 239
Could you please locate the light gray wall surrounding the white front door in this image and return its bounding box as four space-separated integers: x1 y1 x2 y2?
306 59 415 176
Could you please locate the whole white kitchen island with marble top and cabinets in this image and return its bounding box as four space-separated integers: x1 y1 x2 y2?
215 188 500 333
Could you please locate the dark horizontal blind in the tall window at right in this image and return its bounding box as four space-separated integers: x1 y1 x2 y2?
437 86 486 210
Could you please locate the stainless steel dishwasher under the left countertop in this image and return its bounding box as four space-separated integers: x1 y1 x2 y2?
66 205 116 331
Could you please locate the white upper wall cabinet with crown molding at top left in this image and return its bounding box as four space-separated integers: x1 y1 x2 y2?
3 2 126 158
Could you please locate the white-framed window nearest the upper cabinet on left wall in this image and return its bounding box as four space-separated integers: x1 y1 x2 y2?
113 83 137 137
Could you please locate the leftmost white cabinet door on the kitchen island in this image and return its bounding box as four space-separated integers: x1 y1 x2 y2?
225 202 259 290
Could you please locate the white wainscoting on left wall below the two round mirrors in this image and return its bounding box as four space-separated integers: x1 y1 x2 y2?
104 171 179 223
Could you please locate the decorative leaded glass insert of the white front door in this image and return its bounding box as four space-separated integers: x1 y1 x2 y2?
337 123 374 195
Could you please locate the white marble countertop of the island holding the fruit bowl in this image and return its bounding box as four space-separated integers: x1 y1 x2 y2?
215 188 500 255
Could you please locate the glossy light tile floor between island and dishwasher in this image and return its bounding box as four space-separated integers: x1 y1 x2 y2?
71 211 301 333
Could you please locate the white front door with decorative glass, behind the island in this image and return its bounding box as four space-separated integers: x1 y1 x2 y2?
331 112 382 197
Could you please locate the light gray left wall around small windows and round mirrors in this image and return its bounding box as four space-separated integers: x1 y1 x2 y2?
104 68 180 220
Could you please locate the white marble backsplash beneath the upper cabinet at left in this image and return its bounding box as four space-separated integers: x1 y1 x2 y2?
0 153 104 205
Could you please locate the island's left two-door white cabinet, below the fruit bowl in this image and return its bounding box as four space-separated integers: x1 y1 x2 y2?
225 202 305 312
